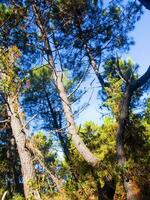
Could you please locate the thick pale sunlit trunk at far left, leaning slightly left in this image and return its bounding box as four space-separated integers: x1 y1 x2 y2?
7 97 40 200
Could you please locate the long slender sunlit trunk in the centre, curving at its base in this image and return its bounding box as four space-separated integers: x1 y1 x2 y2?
32 4 99 167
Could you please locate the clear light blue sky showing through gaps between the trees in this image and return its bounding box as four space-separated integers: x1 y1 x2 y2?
76 9 150 124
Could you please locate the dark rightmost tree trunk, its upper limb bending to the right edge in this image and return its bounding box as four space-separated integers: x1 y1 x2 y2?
117 67 150 200
